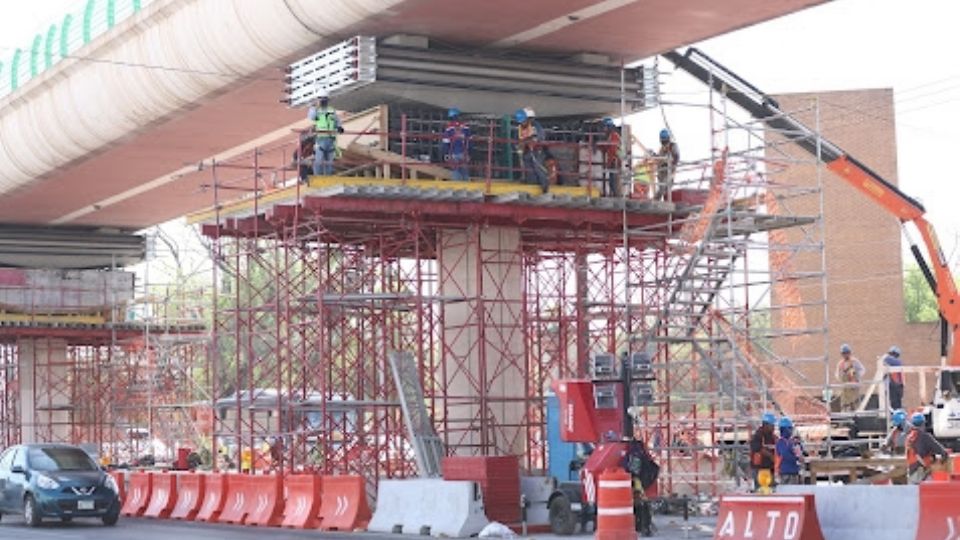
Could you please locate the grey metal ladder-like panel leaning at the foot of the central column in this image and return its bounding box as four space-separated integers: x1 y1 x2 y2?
387 351 445 478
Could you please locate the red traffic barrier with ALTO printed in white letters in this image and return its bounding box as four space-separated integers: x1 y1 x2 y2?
713 495 823 540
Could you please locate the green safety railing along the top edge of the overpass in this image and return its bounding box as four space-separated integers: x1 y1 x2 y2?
0 0 154 98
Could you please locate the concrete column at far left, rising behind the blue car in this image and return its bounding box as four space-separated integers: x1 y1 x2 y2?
17 339 73 443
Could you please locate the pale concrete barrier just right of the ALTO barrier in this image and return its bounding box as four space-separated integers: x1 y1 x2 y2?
777 485 920 540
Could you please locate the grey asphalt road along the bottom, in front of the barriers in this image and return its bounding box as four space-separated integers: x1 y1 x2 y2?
0 515 713 540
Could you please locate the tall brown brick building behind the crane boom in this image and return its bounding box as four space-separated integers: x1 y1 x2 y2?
768 89 940 407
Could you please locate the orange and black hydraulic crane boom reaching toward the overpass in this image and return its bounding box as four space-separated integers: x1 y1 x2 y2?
663 47 960 367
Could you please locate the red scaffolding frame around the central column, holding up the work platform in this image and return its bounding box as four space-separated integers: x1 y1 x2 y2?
195 113 816 493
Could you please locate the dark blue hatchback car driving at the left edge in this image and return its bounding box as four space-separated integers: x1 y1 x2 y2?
0 444 120 527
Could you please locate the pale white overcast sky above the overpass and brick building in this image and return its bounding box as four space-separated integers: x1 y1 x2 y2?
0 0 960 263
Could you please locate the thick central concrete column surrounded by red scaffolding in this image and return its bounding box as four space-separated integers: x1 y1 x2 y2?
438 227 528 454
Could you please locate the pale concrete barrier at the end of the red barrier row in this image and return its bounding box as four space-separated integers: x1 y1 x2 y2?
367 479 489 538
